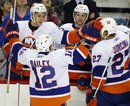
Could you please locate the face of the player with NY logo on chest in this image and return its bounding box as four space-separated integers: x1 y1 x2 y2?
33 13 47 27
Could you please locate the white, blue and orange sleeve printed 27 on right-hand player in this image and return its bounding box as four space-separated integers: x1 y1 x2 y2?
92 45 110 88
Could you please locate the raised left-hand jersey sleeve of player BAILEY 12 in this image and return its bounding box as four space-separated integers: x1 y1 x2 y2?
8 38 27 70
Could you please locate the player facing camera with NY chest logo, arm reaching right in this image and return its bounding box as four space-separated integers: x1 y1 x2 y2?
5 3 102 79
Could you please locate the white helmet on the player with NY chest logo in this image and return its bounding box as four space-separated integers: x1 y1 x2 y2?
30 3 47 21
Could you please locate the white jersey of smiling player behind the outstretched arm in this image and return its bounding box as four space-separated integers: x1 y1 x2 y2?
60 23 91 83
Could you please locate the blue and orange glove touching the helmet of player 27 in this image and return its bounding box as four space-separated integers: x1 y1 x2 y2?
79 18 103 44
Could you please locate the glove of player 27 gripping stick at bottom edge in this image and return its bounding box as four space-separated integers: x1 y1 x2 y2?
86 86 97 106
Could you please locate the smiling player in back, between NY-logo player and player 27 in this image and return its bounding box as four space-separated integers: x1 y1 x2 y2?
61 4 92 91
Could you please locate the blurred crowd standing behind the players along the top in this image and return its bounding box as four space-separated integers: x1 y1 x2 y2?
0 0 99 26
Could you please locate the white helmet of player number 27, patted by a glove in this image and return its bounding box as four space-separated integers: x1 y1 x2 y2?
100 18 117 39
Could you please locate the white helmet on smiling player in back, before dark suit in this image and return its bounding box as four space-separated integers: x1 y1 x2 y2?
73 4 90 23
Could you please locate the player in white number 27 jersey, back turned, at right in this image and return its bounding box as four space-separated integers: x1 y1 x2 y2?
86 18 130 106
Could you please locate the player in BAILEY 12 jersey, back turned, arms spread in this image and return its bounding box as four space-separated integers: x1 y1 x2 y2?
3 20 90 106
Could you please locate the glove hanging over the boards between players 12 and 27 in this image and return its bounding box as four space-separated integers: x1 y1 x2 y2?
77 75 91 91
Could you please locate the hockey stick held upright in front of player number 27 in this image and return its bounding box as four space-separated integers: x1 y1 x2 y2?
93 56 112 98
